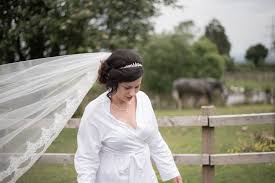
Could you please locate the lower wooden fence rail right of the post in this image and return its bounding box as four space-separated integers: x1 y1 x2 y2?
210 152 275 165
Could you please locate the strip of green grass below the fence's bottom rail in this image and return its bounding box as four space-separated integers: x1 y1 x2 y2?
17 164 275 183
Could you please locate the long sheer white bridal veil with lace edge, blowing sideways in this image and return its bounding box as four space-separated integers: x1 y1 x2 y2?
0 52 110 183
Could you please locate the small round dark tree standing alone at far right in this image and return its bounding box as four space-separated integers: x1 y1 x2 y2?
245 43 268 66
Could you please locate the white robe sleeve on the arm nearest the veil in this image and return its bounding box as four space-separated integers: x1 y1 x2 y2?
74 109 101 183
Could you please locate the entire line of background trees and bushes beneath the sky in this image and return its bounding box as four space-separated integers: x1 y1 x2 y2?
0 0 274 93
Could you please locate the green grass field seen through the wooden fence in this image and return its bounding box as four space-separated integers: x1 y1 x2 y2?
18 105 275 183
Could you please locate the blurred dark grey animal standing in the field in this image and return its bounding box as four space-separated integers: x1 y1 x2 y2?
172 78 227 109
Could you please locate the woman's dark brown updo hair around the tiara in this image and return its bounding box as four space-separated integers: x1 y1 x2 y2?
97 49 143 99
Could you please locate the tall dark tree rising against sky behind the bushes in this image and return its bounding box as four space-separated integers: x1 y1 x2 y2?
205 19 231 56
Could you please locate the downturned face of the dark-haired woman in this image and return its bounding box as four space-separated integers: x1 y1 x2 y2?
114 77 142 102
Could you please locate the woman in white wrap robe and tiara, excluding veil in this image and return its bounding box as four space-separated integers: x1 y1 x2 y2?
74 49 182 183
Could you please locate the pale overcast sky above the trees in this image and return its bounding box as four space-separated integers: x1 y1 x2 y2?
153 0 275 59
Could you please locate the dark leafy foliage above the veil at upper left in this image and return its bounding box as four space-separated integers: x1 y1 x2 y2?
0 0 177 64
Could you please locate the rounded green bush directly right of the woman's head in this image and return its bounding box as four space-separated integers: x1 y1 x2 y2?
141 31 195 93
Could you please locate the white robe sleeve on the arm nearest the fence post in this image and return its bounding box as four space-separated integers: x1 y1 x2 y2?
144 95 180 181
